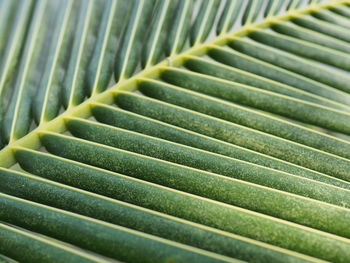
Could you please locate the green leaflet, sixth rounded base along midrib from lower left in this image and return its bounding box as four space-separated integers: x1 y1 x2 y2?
139 78 350 159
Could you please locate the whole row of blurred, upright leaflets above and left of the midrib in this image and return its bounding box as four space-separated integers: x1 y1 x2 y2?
0 0 330 148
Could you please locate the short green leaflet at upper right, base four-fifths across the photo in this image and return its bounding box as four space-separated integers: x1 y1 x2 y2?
271 22 350 53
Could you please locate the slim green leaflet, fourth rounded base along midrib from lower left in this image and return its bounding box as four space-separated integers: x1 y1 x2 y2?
92 105 350 190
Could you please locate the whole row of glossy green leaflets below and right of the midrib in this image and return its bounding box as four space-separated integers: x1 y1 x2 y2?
0 1 350 262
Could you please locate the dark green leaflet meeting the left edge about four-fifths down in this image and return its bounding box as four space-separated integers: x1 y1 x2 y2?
0 193 235 262
